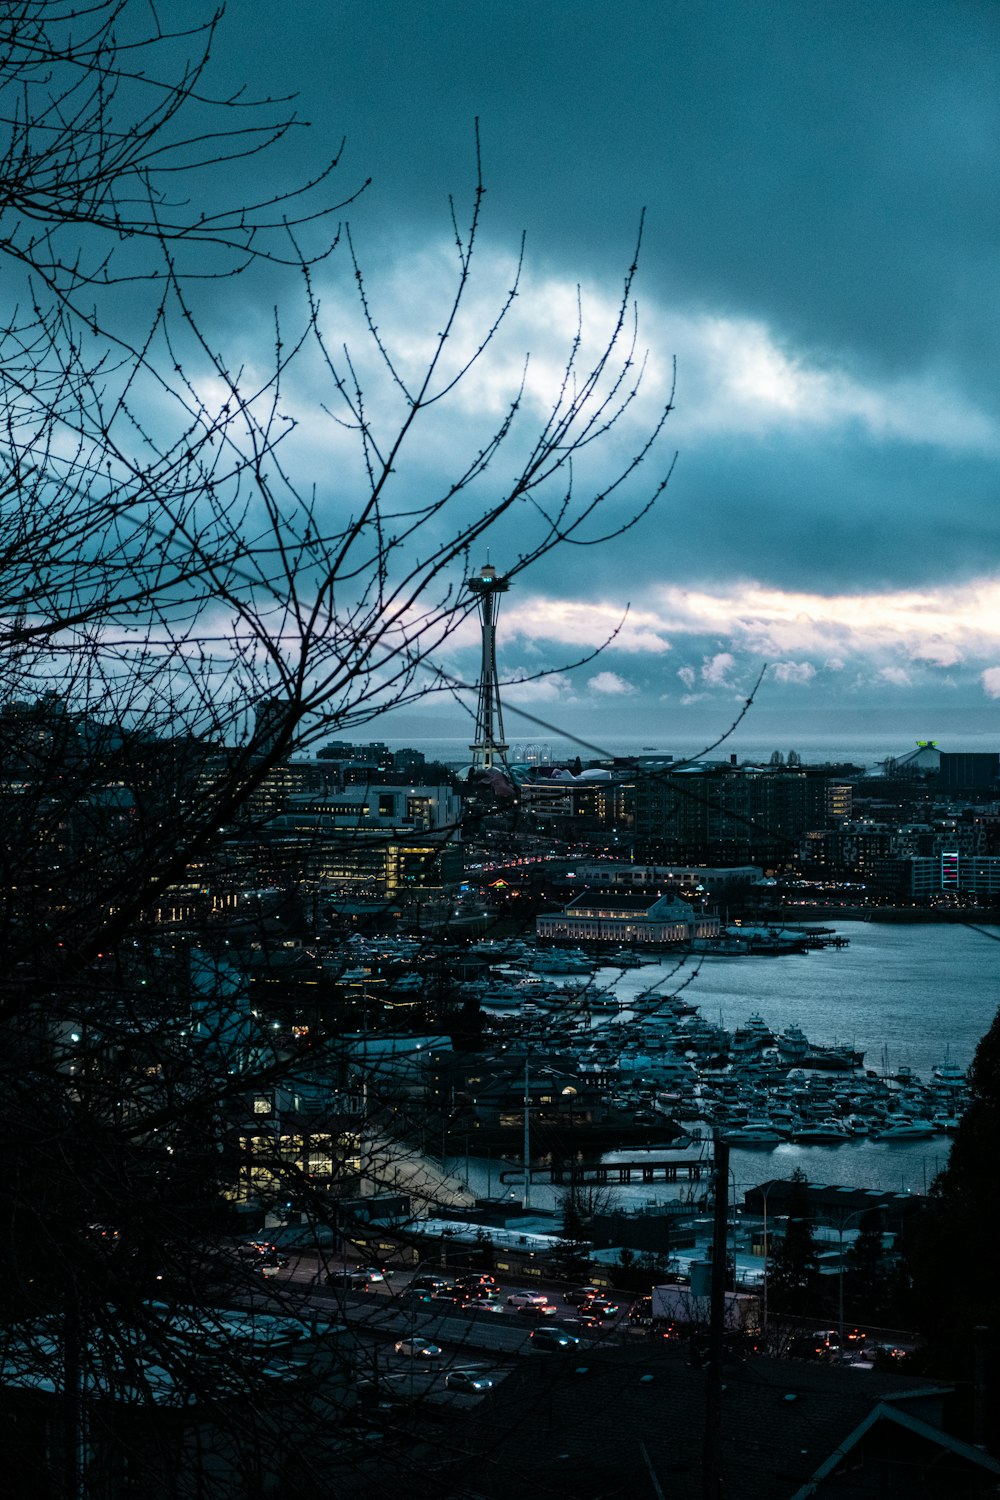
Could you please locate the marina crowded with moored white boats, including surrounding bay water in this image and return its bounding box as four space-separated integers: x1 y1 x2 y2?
449 923 1000 1206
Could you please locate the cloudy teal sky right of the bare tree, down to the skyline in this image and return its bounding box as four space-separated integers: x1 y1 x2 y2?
206 0 1000 762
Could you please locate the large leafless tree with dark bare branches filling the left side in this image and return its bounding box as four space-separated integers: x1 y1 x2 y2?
0 0 680 1496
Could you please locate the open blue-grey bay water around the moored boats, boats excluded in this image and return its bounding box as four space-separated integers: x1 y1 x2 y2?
453 918 1000 1208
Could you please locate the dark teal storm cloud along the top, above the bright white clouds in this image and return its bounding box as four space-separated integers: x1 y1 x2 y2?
232 0 1000 387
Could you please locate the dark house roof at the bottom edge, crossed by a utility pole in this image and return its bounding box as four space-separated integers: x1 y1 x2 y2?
422 1340 996 1500
